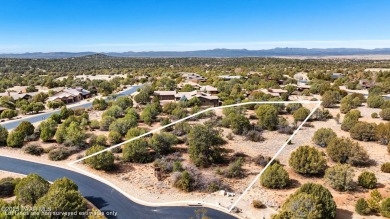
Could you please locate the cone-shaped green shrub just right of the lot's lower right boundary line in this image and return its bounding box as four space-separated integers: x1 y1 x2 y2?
260 163 290 189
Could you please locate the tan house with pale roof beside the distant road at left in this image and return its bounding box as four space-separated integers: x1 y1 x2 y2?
47 88 91 103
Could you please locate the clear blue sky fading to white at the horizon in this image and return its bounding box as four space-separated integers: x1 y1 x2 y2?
0 0 390 53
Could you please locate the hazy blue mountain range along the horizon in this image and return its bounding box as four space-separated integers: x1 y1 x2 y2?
0 48 390 59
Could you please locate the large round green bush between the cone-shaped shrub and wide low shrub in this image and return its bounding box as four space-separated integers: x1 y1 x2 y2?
289 146 326 175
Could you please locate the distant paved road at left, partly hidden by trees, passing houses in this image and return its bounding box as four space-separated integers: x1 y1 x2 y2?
0 86 141 130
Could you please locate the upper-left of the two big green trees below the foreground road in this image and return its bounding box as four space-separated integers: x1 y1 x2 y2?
15 174 50 206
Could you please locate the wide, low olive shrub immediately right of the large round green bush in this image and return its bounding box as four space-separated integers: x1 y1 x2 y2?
326 138 369 166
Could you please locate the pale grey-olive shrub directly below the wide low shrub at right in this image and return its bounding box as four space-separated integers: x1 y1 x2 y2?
325 164 355 191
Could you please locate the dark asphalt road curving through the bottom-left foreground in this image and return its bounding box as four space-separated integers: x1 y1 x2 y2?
0 156 235 219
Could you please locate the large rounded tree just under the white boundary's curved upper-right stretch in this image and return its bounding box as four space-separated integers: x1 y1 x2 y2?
256 104 279 130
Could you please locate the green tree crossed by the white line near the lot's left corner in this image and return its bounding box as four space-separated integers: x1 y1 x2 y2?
85 145 115 170
